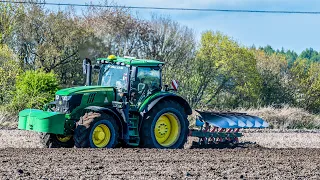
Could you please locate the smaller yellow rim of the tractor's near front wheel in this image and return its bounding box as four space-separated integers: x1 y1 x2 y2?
92 124 111 148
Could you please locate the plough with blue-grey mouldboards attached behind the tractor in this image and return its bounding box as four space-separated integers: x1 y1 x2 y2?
189 110 269 146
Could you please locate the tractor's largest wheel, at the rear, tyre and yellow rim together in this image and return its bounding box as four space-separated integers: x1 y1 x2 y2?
140 100 189 149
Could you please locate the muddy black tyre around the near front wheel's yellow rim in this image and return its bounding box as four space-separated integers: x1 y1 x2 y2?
74 112 119 148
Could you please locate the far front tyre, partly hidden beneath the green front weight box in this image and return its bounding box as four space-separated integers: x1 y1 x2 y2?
40 133 74 148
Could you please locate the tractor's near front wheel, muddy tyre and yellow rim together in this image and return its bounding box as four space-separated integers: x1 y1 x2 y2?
74 112 119 148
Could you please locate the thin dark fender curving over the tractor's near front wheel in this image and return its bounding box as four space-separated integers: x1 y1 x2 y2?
85 106 126 138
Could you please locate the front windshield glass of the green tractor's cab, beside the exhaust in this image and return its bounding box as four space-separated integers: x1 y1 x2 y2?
99 64 128 91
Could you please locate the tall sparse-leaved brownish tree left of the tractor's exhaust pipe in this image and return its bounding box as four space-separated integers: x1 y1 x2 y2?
14 5 87 84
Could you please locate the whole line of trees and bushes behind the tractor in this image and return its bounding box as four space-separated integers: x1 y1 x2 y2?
0 3 320 113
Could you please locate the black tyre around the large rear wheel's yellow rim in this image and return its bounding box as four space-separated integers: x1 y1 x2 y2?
140 100 189 149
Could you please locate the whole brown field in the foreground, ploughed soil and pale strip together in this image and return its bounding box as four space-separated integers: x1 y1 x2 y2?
0 130 320 179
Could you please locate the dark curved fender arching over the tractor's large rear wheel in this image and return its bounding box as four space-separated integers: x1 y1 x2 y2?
139 91 192 115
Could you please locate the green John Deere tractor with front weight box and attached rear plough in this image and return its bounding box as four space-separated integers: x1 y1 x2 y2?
18 55 268 148
